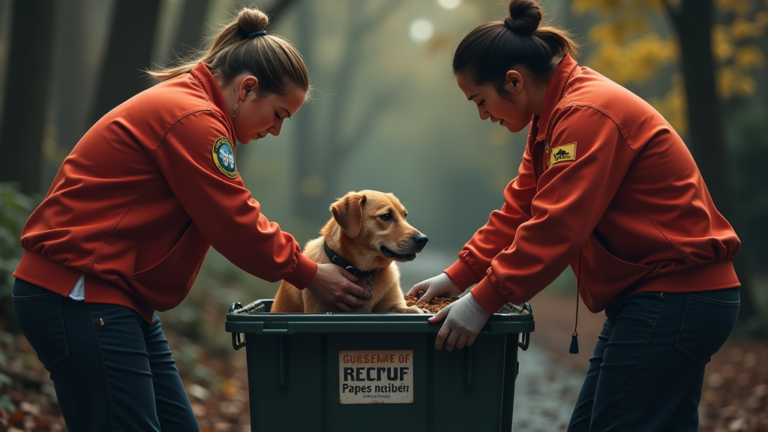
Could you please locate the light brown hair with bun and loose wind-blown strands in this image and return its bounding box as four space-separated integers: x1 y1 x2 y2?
147 8 309 95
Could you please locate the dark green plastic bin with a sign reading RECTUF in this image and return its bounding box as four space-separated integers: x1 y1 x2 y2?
226 300 534 432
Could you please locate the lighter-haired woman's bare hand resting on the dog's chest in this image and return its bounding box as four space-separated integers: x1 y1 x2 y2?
307 264 371 312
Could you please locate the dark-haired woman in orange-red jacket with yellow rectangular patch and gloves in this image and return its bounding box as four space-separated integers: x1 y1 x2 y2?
409 0 740 432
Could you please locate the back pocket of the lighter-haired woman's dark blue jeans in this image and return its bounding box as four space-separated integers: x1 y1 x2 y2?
13 279 69 371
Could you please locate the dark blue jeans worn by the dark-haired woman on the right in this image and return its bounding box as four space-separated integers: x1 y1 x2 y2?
568 288 739 432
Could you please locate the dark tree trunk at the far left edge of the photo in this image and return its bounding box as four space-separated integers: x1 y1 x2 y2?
0 0 58 194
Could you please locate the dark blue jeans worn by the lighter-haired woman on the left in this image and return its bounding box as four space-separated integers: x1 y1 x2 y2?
13 279 198 432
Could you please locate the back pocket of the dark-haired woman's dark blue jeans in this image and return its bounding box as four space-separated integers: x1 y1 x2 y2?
675 288 739 364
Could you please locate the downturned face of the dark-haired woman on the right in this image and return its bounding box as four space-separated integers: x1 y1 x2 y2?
456 71 533 133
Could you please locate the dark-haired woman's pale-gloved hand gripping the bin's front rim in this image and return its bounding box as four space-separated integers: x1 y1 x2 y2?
428 293 491 351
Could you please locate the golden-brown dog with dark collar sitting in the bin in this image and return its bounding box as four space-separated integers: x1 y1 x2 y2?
271 190 427 313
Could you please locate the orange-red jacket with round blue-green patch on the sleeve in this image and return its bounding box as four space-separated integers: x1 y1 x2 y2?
14 63 317 321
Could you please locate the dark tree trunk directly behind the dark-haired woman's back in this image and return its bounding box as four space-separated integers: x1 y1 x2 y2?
668 0 758 320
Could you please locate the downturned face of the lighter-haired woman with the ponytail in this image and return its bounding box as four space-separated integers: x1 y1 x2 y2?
232 76 307 144
